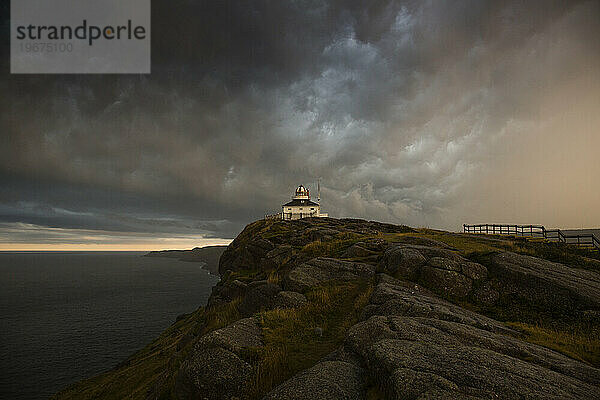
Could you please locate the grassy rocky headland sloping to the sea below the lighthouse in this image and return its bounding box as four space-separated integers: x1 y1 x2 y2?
57 218 600 400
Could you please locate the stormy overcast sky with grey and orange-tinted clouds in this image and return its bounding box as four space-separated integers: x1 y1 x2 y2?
0 0 600 249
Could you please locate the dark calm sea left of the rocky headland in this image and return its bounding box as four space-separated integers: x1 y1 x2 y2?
0 252 218 400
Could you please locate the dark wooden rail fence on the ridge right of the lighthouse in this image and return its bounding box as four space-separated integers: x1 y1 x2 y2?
463 224 600 250
